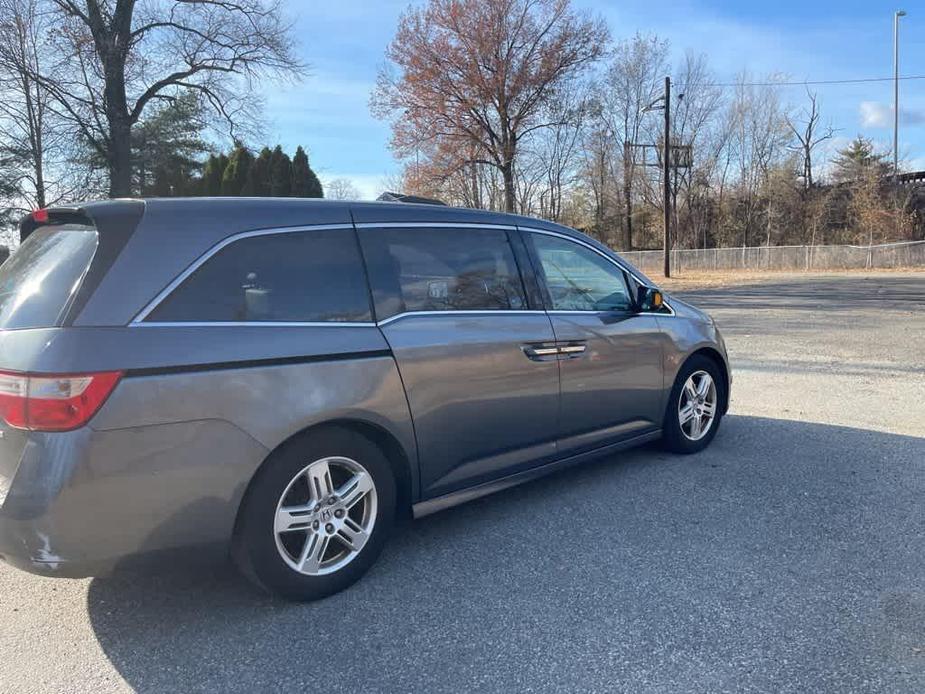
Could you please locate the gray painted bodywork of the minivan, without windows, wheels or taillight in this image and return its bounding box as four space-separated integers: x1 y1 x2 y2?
0 199 728 575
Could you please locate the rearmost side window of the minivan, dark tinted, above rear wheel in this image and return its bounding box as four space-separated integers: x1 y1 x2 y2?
145 229 371 323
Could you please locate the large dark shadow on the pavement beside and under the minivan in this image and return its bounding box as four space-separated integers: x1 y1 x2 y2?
88 415 925 692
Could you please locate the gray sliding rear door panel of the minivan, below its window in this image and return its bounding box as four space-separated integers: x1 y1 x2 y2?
383 312 559 495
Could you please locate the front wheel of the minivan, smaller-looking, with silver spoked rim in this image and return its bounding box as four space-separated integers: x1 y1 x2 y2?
662 355 726 454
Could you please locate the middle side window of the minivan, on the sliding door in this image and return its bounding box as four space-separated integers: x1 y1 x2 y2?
361 228 527 319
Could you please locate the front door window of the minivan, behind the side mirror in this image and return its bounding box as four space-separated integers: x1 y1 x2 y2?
531 233 632 311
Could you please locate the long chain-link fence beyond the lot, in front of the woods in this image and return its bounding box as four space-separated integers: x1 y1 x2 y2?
620 241 925 275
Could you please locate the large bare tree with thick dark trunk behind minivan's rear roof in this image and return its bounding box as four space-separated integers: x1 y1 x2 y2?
33 0 304 196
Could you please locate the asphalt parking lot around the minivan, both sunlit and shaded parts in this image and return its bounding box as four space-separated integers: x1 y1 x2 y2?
0 273 925 693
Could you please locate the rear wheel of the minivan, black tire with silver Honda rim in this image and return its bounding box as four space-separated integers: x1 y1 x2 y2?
232 427 396 601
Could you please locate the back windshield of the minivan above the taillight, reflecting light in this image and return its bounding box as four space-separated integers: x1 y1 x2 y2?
0 225 99 330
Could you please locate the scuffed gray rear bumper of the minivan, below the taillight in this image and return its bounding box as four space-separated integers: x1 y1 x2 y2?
0 420 267 577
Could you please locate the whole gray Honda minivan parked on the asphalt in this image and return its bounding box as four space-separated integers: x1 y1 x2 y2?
0 198 730 600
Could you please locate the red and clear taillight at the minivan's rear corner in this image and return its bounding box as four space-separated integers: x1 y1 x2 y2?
0 371 122 431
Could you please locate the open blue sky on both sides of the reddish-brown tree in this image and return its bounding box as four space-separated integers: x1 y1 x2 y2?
266 0 925 197
